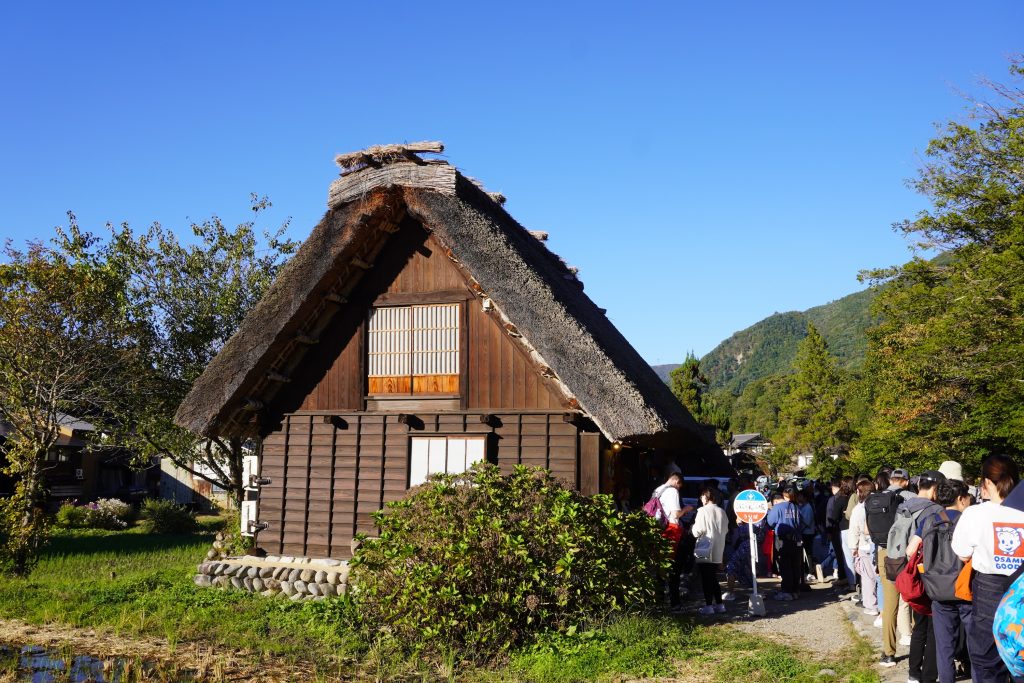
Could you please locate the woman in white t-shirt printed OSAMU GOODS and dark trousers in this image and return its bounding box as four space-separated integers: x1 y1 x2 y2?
952 455 1024 682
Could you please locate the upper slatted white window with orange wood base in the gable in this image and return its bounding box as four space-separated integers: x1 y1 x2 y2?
368 303 460 394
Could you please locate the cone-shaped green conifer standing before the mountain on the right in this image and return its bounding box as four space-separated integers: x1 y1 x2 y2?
775 324 853 473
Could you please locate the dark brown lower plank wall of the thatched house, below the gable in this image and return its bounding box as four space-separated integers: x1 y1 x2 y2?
257 411 597 559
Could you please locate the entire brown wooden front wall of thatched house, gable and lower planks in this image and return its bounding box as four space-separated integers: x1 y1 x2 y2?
257 232 600 559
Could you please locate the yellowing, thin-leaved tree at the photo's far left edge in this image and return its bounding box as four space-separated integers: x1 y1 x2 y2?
0 222 145 575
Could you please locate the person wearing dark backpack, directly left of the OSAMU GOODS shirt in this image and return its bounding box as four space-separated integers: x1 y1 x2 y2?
906 479 971 683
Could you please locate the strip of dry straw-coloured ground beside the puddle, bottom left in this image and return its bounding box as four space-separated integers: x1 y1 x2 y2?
0 620 314 683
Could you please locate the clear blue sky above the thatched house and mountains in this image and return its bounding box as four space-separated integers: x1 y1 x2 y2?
0 0 1024 364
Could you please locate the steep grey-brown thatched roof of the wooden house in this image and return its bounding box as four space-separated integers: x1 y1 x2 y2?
175 142 698 441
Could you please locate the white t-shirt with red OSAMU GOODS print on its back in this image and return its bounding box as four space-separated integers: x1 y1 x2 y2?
952 503 1024 577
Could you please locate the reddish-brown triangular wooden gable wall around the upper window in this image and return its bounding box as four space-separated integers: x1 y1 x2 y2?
298 232 563 411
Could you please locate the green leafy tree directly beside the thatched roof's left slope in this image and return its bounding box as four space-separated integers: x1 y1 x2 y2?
121 195 298 504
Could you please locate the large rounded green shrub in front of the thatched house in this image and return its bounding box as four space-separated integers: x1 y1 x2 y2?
351 465 668 657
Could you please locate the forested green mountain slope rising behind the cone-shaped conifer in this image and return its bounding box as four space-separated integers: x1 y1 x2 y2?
700 290 874 394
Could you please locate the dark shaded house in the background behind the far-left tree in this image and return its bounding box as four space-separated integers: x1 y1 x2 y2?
0 415 159 507
